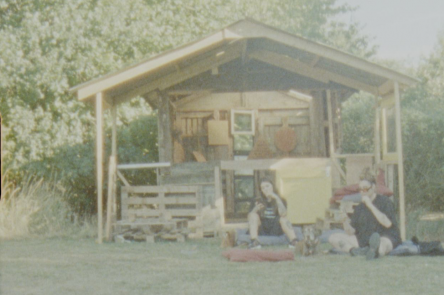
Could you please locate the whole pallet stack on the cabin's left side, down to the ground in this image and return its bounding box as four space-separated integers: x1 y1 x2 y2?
114 185 203 241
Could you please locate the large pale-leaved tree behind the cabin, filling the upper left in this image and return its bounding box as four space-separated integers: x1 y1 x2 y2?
0 0 374 215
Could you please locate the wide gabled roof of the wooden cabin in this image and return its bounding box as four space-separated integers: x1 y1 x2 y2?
71 19 418 103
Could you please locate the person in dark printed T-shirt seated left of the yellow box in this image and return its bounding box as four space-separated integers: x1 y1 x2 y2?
248 179 296 249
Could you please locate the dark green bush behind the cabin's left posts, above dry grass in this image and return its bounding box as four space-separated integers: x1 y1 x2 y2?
13 110 158 216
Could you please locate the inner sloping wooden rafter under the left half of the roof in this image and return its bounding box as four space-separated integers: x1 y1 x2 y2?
111 42 242 103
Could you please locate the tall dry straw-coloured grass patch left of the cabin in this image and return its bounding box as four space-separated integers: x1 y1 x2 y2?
0 177 96 239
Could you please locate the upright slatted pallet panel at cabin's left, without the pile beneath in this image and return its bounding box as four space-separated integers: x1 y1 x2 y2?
122 185 203 237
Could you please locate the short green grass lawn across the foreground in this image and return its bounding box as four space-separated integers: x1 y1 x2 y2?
0 239 444 295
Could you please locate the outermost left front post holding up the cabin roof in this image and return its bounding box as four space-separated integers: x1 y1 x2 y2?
96 92 103 244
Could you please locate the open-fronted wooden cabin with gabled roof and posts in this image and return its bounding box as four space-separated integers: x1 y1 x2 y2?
72 19 417 241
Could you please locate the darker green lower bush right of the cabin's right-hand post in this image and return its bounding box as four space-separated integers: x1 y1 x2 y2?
402 90 444 211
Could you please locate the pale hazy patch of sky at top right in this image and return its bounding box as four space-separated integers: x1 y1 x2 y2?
337 0 444 64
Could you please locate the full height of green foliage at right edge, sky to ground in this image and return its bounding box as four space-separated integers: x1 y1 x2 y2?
402 36 444 211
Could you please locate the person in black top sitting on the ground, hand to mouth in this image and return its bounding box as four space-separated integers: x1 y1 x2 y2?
329 170 402 260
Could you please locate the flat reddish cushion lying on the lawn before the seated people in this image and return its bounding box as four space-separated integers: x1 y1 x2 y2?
222 249 294 262
